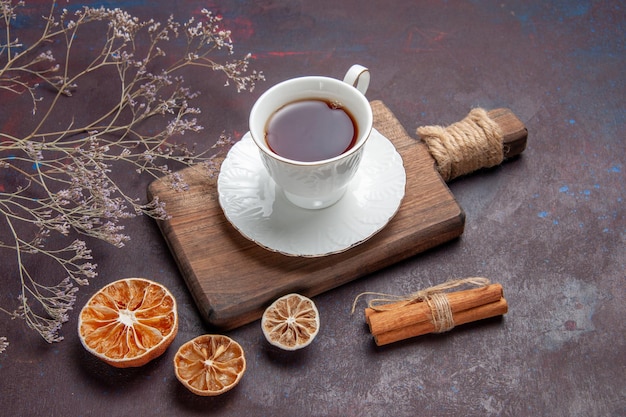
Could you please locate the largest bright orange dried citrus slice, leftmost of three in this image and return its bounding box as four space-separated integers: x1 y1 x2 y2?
78 278 178 368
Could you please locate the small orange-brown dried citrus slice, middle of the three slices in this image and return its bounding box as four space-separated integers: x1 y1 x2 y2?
174 334 246 397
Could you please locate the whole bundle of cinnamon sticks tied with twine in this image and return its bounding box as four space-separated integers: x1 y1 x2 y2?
352 277 508 346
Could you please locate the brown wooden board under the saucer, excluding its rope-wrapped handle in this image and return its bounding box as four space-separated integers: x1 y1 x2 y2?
148 101 465 330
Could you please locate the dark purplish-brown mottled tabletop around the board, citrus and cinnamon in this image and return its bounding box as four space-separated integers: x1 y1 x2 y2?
0 0 626 417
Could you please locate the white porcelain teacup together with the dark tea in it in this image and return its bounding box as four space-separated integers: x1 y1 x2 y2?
250 65 373 209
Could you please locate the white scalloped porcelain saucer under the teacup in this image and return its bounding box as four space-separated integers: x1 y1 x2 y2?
217 129 406 257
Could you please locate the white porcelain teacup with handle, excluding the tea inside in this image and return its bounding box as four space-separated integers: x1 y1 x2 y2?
250 65 373 209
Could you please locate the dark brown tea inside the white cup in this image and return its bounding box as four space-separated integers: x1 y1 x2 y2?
265 99 359 162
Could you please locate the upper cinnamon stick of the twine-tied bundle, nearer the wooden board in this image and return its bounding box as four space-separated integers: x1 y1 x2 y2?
365 284 503 335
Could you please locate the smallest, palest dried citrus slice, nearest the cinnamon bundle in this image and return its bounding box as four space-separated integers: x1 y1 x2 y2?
261 294 320 350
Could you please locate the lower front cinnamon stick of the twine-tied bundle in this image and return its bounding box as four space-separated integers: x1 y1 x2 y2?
374 298 508 346
